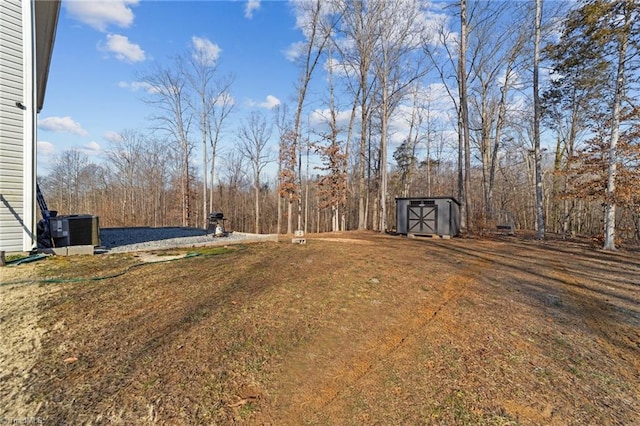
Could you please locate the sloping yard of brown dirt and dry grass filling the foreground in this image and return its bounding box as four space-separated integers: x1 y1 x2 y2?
0 232 640 425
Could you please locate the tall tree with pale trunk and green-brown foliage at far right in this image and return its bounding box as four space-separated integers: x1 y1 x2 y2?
550 0 640 250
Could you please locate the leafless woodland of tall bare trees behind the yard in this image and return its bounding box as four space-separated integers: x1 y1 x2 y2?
39 0 640 249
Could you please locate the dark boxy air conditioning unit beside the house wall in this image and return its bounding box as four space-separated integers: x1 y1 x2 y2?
49 214 100 247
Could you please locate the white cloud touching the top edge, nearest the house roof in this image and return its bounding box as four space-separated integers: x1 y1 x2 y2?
62 0 138 32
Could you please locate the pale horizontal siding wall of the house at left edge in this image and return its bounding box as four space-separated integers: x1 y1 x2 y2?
0 0 35 252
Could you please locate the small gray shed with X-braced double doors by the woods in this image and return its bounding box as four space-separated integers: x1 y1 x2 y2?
396 197 460 237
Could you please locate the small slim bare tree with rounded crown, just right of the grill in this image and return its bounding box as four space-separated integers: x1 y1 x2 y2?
238 111 272 234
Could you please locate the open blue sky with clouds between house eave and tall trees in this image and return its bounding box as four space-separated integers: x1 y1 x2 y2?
38 0 303 174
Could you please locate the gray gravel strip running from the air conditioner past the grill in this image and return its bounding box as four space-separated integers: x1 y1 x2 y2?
100 227 278 253
